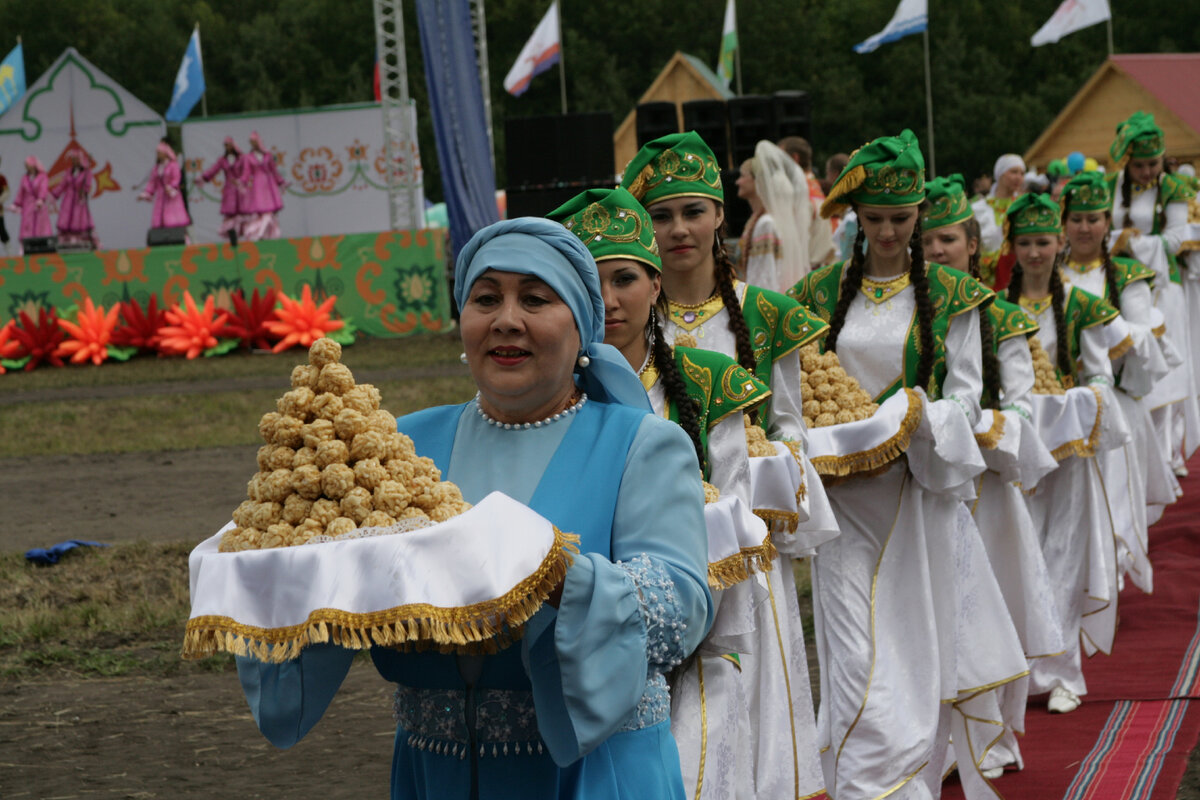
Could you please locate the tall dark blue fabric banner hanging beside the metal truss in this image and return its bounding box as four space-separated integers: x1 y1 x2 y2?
416 0 499 255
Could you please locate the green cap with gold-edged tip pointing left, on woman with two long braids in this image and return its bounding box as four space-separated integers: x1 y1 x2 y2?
821 128 925 218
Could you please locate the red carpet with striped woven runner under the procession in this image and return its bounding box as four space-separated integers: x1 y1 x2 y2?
942 457 1200 800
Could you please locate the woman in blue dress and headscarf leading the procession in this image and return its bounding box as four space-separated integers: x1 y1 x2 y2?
238 218 712 800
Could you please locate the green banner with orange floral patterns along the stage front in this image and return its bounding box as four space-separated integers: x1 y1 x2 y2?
0 229 451 336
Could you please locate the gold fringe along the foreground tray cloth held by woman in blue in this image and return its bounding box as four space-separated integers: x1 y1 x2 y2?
181 528 580 663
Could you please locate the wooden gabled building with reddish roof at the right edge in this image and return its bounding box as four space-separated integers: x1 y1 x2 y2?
1025 53 1200 169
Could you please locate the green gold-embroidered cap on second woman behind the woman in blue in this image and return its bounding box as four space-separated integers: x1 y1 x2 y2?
620 131 725 207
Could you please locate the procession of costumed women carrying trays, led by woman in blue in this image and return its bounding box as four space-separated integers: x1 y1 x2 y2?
226 113 1200 800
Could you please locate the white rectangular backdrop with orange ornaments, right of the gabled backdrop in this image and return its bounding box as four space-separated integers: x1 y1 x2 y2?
182 103 425 242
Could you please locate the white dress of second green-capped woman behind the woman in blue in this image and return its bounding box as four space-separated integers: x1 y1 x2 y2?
662 282 838 800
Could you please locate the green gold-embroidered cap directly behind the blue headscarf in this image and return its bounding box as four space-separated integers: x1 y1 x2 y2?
546 186 662 272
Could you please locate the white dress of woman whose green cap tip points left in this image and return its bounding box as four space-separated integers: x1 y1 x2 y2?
814 285 1027 800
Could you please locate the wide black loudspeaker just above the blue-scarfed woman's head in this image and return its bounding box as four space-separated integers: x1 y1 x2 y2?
504 112 616 190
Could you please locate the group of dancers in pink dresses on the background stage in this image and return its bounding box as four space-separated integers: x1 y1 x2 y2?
0 131 288 255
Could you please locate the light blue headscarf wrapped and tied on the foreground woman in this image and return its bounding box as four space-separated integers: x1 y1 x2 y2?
454 217 652 411
